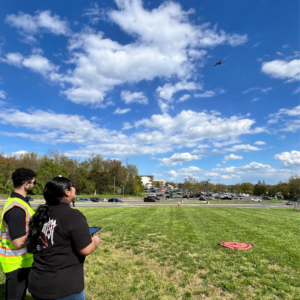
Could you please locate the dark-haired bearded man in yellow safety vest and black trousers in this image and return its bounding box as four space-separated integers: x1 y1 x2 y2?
0 168 36 300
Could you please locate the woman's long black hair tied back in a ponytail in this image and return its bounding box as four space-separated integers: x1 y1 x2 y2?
25 177 71 253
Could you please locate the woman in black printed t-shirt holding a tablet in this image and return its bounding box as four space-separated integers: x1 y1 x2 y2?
26 177 100 300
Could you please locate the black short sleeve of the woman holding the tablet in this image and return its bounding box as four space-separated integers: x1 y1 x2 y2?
70 210 92 250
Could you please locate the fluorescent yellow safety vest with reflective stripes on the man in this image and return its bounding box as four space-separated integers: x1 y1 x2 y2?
0 198 34 273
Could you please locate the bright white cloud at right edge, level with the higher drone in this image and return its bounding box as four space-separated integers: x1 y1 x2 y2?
261 59 300 82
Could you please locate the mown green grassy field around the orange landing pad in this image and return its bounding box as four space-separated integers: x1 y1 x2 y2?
0 207 300 300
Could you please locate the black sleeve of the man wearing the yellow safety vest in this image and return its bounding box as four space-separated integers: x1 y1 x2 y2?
4 206 26 240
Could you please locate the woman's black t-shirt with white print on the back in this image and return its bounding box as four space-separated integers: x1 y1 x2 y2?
28 203 92 299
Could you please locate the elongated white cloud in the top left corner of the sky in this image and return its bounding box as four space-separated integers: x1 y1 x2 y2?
5 10 70 35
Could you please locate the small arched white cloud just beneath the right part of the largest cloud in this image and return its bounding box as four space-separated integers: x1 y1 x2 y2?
156 81 202 101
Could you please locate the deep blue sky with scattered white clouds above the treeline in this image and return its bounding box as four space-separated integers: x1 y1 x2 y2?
0 0 300 184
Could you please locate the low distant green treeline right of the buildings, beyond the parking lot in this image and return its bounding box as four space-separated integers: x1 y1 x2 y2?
178 175 300 200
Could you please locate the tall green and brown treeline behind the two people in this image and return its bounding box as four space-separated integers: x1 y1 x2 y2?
0 150 144 195
